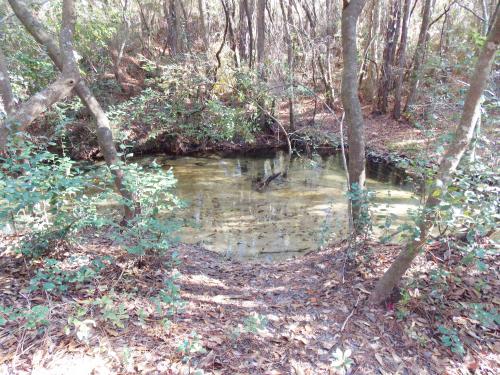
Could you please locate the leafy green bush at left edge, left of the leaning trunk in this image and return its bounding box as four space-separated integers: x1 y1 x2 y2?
0 138 95 257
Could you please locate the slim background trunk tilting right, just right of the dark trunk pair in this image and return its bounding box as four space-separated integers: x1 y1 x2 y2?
405 0 433 112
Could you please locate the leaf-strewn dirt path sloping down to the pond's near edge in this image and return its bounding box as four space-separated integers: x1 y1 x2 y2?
175 242 410 374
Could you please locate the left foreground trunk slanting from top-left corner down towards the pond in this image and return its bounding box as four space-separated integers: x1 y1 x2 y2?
8 0 140 220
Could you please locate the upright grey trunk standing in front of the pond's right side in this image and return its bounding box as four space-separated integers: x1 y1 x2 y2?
342 0 366 230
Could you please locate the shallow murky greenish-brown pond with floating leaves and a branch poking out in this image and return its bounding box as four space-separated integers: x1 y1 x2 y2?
146 153 417 260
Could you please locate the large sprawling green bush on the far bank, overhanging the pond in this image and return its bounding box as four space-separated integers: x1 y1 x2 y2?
104 61 271 144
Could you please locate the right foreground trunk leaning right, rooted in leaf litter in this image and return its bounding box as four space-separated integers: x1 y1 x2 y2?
370 13 500 304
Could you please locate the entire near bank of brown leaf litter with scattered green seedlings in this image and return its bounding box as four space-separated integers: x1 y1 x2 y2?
0 236 499 374
